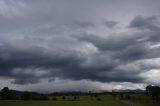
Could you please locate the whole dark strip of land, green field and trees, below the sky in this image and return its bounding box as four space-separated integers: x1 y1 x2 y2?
0 85 160 106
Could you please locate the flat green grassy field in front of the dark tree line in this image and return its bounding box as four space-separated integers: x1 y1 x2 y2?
0 95 160 106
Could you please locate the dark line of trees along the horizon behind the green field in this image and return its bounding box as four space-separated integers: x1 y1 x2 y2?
0 85 160 101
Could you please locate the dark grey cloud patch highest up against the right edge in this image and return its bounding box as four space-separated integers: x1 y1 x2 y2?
130 16 160 43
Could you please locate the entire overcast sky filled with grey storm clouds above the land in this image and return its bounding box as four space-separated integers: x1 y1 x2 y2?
0 0 160 92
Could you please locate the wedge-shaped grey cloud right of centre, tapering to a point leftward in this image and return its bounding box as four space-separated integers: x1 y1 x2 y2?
77 33 159 63
